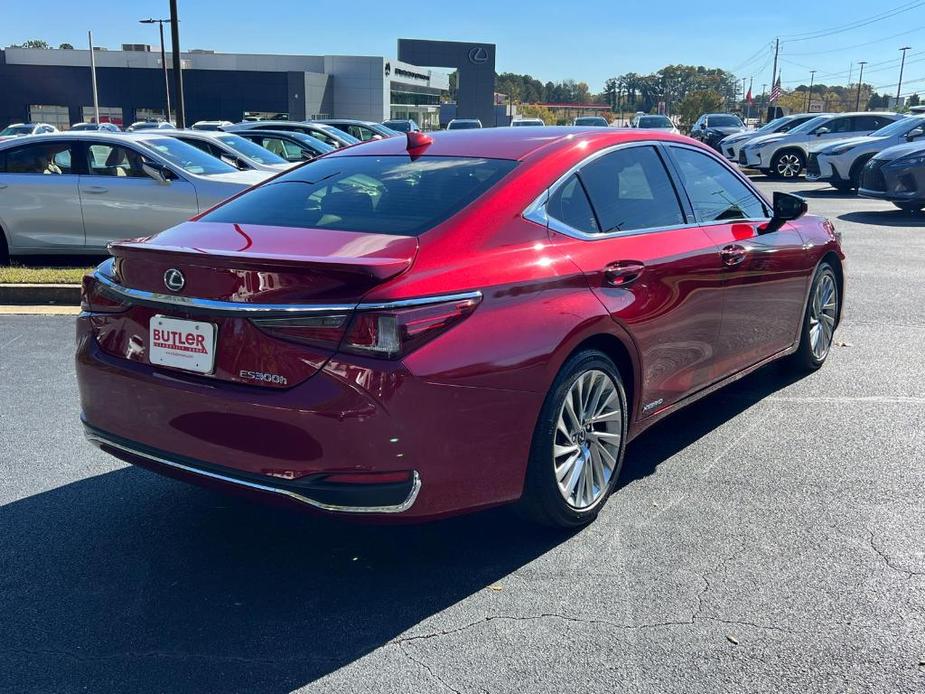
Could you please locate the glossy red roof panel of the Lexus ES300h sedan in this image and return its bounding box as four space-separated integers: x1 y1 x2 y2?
328 125 692 160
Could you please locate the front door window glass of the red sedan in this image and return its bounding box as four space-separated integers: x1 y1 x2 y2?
671 147 767 223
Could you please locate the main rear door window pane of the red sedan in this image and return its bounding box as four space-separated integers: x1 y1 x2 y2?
578 146 684 233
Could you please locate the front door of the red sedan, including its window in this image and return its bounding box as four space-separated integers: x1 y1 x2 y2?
668 144 811 378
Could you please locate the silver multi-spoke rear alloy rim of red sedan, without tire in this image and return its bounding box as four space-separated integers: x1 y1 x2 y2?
552 369 623 511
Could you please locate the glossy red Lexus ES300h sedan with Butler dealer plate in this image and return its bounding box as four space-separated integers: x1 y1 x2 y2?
77 128 844 526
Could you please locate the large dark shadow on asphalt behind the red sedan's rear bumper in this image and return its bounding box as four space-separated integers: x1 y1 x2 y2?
0 467 571 694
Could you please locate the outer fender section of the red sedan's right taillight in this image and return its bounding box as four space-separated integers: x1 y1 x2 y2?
340 298 479 359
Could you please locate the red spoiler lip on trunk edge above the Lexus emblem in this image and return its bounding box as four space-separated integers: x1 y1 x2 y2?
108 241 416 281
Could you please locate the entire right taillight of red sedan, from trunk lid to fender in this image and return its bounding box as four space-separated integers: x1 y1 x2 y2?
254 297 481 359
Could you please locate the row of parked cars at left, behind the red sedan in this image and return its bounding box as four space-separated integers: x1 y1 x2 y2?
0 114 412 260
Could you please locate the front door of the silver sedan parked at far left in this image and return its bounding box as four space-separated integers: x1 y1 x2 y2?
80 140 199 250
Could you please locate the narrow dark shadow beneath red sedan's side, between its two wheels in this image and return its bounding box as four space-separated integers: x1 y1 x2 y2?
617 363 806 493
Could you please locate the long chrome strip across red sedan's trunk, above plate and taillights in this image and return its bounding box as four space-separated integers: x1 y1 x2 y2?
93 270 482 317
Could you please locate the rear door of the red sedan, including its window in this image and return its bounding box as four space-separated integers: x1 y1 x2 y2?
546 144 723 416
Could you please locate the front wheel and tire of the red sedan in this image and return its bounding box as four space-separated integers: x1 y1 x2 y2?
791 262 841 371
